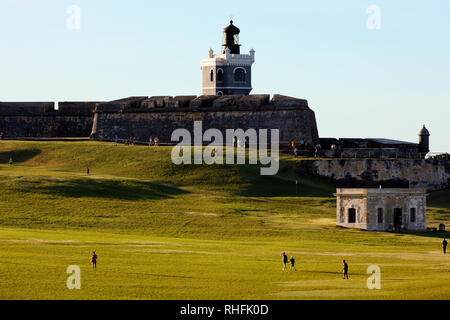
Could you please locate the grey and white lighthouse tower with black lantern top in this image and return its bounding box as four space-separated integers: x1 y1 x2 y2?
201 20 255 95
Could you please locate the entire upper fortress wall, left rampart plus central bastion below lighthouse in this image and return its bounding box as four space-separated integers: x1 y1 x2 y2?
0 95 319 145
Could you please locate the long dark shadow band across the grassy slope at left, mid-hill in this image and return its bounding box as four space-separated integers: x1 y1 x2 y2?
19 178 189 200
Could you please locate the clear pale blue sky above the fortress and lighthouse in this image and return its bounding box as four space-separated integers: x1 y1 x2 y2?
0 0 450 152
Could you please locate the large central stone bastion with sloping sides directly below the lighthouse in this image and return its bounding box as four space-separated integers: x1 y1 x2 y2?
91 95 319 145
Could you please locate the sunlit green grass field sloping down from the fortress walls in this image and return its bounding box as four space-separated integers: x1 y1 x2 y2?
0 141 450 299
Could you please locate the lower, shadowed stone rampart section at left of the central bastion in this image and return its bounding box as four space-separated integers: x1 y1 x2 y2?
0 102 98 138
